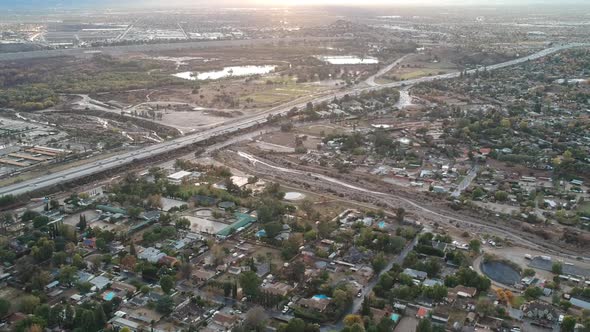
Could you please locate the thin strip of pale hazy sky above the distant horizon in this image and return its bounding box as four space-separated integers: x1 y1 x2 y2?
0 0 588 9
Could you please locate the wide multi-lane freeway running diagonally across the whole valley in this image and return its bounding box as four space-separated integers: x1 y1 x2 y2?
0 44 590 196
